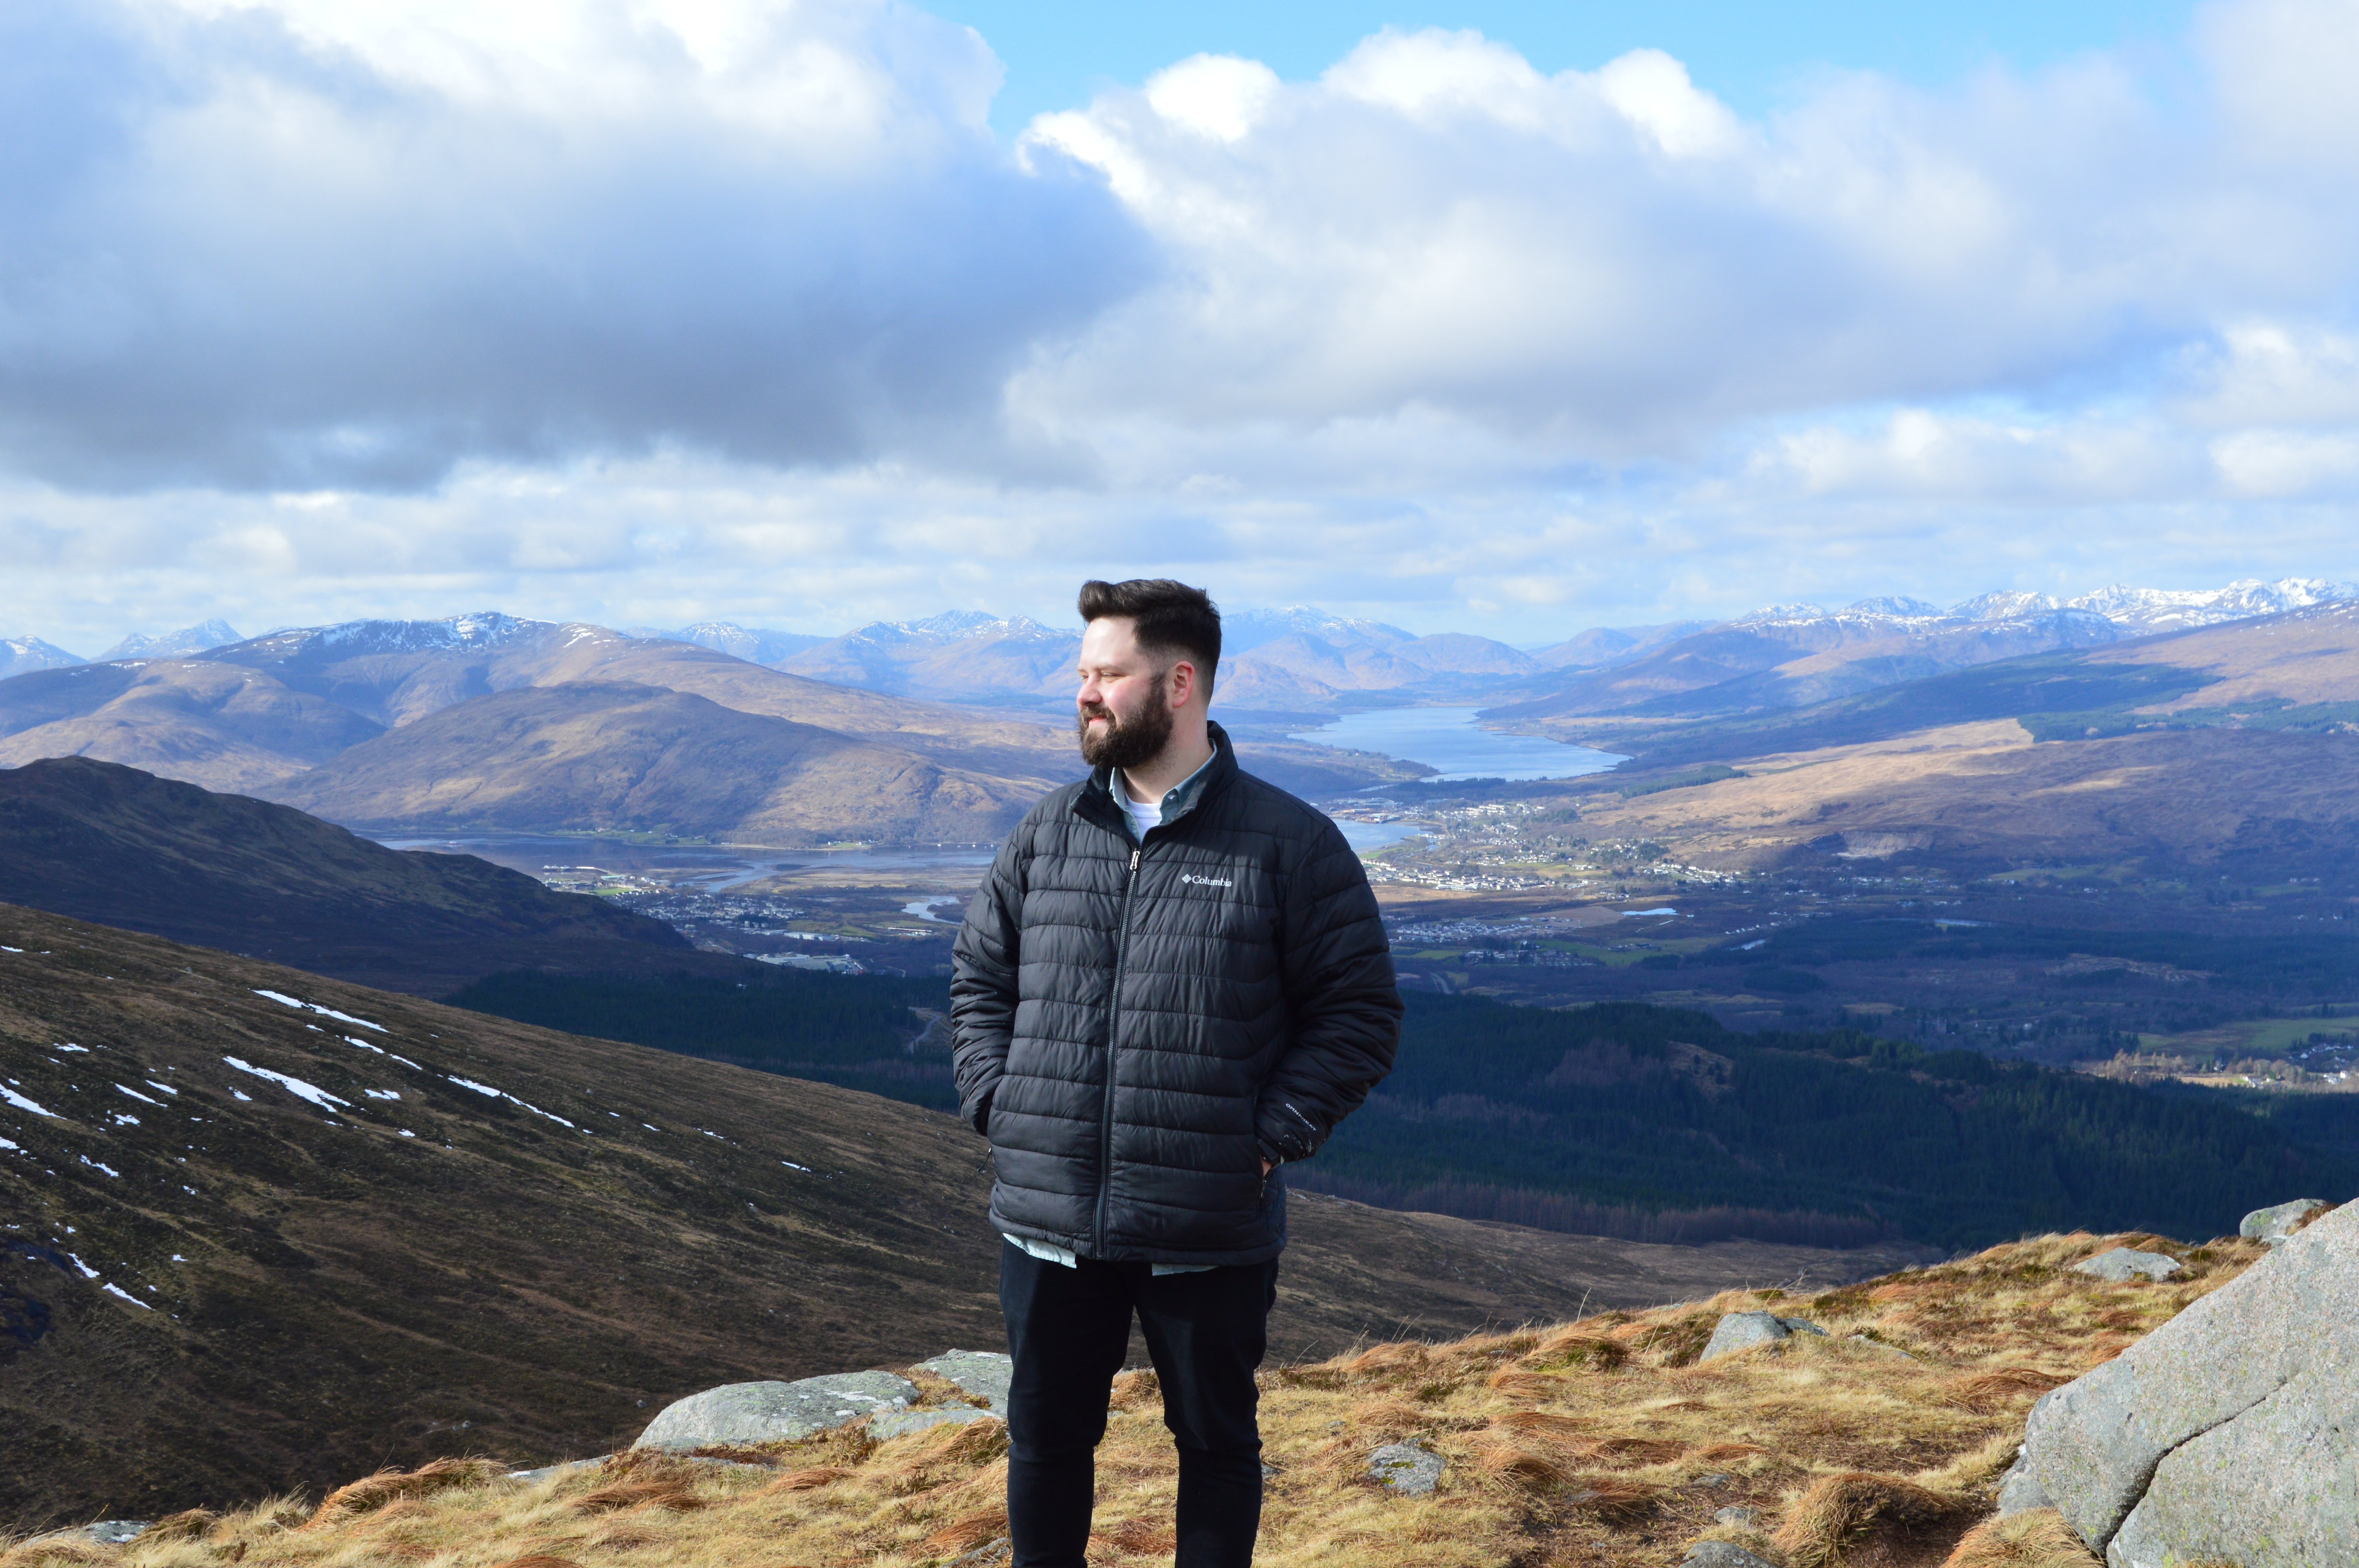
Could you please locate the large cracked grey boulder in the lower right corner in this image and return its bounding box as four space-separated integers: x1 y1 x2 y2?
2024 1205 2359 1568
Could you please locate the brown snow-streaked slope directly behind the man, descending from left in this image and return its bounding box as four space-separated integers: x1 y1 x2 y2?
0 906 1892 1523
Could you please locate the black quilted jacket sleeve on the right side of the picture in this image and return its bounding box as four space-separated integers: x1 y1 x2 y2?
1255 823 1401 1160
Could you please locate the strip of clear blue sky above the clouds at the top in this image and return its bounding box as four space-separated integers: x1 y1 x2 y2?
939 0 2192 134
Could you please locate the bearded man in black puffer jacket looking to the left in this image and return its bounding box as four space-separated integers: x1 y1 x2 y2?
951 580 1401 1568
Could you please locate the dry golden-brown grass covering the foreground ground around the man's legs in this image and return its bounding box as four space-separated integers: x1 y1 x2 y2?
46 1236 2260 1568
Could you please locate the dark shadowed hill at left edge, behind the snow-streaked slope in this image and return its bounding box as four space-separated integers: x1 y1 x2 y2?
0 757 707 995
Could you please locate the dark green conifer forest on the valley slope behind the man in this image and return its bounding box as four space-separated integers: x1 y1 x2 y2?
453 971 2359 1247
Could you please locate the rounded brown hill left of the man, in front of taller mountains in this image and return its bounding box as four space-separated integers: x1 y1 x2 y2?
274 681 1043 844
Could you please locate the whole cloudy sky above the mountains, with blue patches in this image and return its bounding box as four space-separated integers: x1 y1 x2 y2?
0 0 2359 653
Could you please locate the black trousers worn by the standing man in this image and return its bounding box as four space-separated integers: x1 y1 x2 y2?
1000 1245 1279 1568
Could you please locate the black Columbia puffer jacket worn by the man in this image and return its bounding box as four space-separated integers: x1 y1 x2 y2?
951 724 1401 1264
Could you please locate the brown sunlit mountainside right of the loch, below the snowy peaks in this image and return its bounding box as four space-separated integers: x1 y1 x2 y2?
1533 599 2359 877
